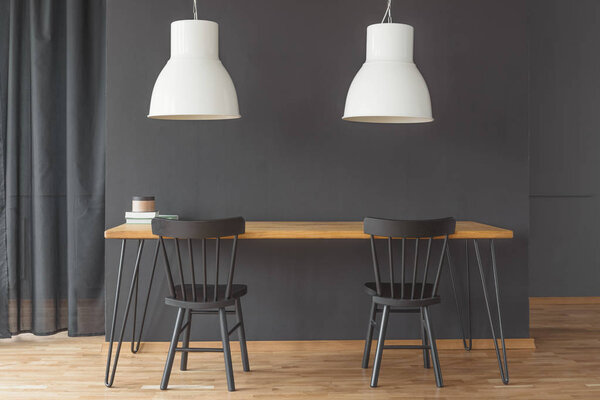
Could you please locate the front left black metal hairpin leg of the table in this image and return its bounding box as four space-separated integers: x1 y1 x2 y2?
104 239 144 387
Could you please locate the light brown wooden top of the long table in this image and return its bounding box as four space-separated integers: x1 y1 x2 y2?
104 221 513 239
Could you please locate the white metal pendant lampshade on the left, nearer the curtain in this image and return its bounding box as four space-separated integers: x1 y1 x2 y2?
148 20 240 120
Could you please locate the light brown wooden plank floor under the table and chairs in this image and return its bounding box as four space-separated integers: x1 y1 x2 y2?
0 304 600 400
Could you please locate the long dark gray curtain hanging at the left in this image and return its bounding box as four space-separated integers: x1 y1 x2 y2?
0 0 105 337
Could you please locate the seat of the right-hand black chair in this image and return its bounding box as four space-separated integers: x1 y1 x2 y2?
365 282 440 307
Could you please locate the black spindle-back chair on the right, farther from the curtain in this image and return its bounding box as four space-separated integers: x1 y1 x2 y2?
362 218 456 387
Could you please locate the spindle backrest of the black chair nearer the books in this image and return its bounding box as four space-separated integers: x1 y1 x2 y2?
152 217 246 302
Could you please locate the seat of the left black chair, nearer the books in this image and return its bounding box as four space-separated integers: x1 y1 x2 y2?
165 284 248 309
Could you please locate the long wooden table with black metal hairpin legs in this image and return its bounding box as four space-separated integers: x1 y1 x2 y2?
104 221 513 387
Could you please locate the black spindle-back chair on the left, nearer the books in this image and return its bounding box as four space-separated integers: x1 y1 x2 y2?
152 217 250 391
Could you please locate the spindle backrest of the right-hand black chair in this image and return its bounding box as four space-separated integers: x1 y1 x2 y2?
364 218 456 300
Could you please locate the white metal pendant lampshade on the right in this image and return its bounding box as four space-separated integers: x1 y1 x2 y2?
342 23 433 124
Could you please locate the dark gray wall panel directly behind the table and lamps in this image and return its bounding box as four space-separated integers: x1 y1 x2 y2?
106 0 529 340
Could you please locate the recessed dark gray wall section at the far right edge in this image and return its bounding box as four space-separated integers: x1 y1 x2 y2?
529 0 600 296
